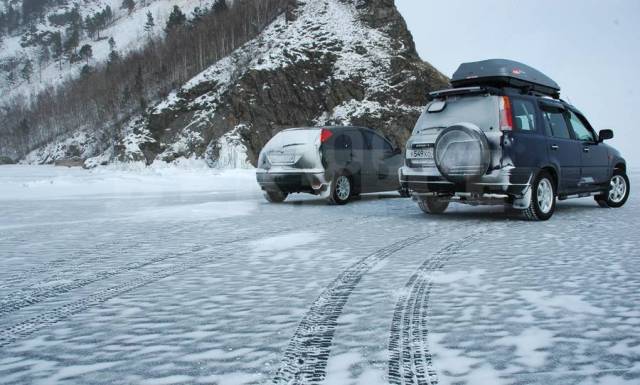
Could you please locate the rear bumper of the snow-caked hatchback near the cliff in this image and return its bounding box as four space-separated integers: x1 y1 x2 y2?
256 169 329 194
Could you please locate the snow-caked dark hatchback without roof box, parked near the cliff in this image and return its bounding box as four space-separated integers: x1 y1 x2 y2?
256 127 403 204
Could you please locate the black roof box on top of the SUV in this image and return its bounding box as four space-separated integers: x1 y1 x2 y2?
451 59 560 98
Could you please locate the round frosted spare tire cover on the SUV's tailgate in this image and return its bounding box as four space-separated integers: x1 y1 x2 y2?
434 123 491 183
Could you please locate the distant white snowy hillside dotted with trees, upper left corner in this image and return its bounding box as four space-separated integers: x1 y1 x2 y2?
0 0 213 104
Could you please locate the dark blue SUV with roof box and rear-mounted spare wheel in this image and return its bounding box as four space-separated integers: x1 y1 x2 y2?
399 59 629 220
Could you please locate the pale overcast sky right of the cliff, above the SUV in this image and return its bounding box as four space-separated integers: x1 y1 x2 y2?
396 0 640 168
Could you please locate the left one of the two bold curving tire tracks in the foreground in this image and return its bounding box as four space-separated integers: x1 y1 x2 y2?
273 233 436 384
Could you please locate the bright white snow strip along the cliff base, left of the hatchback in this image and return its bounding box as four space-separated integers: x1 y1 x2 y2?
0 161 259 201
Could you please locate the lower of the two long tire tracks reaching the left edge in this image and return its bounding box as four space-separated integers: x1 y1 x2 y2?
0 216 387 347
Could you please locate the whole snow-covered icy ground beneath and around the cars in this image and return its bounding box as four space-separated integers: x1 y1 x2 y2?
0 166 640 385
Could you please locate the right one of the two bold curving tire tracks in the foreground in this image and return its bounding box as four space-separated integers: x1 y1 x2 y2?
388 229 489 385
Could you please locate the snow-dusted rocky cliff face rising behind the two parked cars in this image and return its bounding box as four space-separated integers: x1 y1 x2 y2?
23 0 448 167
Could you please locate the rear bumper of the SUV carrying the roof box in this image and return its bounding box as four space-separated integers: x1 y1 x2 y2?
398 166 535 198
